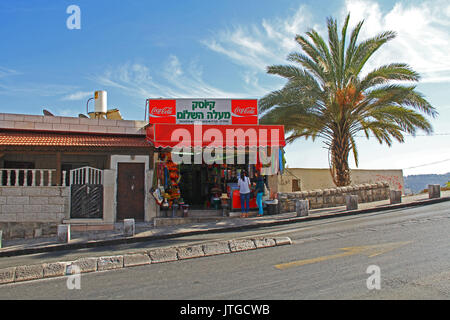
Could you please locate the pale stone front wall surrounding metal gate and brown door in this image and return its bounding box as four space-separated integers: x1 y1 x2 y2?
0 155 157 231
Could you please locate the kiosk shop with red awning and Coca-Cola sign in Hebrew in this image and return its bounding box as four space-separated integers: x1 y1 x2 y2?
146 99 285 217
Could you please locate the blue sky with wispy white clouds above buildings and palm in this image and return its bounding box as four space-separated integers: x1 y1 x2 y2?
0 0 450 174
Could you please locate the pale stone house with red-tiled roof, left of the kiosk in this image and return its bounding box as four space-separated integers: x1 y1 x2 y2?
0 113 156 238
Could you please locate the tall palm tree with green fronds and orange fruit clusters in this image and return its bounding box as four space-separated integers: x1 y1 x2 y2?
259 15 438 186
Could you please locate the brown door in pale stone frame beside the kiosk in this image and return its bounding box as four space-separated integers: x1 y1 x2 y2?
117 163 145 220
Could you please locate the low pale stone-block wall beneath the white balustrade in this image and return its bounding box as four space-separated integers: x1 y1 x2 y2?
0 187 70 239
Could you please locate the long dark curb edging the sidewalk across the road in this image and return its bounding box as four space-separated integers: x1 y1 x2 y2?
0 197 450 258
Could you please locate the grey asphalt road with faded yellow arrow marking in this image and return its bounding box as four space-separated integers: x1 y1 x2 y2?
0 202 450 300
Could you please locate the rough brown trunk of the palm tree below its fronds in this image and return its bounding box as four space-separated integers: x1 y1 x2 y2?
330 134 351 187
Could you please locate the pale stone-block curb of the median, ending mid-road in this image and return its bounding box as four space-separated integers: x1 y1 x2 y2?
0 237 292 285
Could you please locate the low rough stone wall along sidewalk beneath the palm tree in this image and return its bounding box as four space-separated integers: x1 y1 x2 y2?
278 182 389 213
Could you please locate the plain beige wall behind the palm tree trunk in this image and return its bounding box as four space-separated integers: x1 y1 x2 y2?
269 168 404 192
